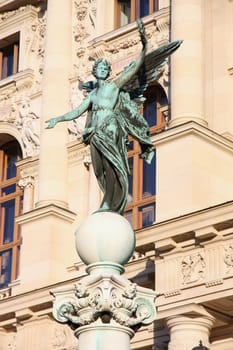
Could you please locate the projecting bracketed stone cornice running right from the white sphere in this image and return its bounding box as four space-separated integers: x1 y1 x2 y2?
136 201 233 253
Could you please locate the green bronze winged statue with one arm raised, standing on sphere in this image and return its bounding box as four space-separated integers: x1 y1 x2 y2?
47 20 181 214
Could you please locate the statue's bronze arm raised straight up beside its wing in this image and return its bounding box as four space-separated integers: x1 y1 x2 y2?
114 19 147 88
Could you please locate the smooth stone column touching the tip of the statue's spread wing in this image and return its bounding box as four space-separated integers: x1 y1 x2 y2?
170 0 206 126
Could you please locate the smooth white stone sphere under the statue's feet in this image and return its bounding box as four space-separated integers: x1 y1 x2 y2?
75 211 135 265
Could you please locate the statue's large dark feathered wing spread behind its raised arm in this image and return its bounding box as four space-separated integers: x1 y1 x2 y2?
123 40 182 99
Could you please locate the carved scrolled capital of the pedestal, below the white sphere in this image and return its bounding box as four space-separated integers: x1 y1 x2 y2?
52 274 155 330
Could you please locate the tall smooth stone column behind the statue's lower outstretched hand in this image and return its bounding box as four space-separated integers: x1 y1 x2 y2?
36 0 72 208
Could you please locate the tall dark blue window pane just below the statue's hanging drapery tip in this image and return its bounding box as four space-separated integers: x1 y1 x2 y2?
142 156 156 198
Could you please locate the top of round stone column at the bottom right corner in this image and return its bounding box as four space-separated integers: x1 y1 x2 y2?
167 315 214 350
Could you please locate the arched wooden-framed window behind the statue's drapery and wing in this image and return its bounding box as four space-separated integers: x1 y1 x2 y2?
124 85 167 229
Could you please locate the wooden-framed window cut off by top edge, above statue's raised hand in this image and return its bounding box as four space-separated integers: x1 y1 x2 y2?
116 0 159 28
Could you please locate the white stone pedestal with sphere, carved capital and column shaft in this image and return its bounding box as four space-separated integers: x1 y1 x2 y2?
52 212 156 350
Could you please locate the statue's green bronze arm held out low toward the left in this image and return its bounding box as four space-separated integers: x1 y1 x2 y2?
46 94 91 129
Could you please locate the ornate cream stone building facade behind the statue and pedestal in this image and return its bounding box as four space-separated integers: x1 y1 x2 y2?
0 0 233 350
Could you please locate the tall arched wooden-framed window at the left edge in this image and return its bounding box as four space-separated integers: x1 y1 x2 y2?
0 135 22 288
